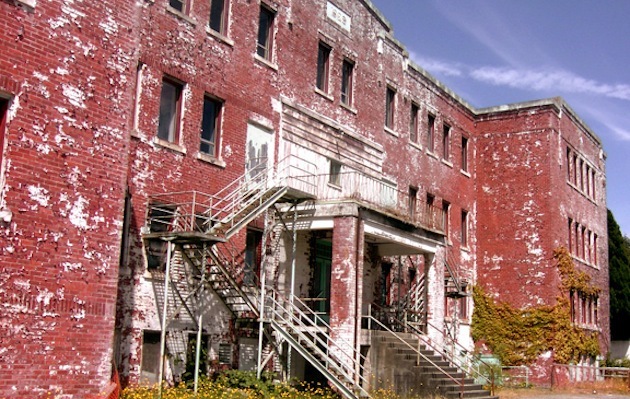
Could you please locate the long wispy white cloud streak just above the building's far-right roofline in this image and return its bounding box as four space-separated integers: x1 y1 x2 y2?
470 67 630 101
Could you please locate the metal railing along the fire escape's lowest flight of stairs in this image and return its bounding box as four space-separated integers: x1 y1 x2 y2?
263 289 368 396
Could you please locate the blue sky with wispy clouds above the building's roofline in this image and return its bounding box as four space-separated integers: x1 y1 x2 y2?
372 0 630 236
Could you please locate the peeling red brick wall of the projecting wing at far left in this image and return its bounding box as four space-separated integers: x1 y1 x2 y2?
0 1 135 398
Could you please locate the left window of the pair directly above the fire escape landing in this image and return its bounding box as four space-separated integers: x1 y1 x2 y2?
158 78 184 143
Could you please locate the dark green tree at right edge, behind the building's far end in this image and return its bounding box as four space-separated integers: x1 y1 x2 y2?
608 210 630 340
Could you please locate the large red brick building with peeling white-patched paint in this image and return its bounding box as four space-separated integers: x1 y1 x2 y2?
0 0 609 397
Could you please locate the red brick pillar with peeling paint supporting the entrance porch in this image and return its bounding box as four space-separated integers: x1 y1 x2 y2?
330 216 363 366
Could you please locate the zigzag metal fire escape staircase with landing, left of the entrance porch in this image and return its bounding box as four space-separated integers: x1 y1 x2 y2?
143 158 368 399
